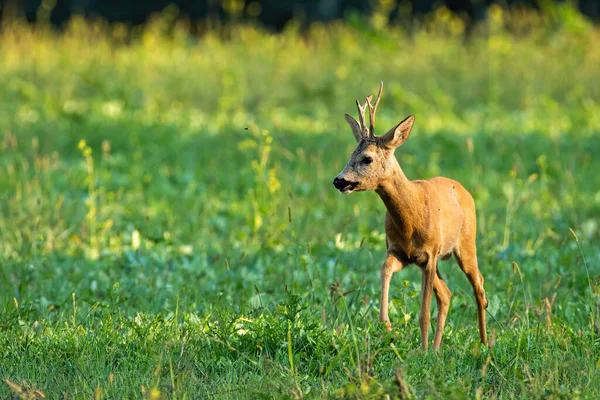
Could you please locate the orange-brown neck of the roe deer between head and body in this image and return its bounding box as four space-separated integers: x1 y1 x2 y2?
375 162 424 231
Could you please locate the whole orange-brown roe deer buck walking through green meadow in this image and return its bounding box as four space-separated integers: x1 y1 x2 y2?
333 82 487 351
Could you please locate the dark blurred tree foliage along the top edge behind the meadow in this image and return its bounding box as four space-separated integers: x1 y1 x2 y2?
0 0 600 30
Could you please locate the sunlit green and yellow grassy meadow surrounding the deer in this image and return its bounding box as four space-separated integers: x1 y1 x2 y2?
0 4 600 399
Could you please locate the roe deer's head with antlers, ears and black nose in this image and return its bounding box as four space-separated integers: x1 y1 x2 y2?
333 82 415 194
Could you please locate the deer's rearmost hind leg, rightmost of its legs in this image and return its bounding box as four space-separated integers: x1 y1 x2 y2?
454 239 488 344
